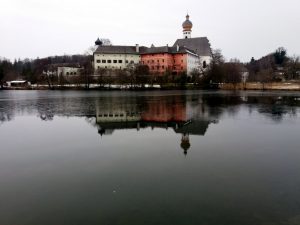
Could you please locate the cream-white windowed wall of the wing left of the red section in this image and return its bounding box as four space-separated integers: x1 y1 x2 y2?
94 53 141 70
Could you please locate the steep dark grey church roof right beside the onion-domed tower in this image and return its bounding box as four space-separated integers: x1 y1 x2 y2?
173 37 212 56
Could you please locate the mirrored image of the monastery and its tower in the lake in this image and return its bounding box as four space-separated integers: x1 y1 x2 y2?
96 96 212 154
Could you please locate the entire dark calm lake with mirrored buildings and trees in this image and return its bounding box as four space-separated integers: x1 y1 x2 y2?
0 91 300 225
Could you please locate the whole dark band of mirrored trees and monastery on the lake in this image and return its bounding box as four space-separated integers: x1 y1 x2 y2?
0 91 300 154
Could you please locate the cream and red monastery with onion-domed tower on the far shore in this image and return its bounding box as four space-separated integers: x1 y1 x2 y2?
93 15 212 75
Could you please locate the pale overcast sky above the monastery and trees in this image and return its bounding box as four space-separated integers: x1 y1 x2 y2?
0 0 300 61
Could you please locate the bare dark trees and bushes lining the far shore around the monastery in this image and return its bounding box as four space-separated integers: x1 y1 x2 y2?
0 47 300 88
